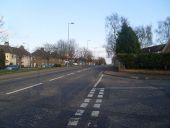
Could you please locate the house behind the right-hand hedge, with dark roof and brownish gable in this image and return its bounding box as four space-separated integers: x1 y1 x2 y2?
142 39 170 53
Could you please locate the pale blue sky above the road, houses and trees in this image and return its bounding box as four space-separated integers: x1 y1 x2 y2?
0 0 170 63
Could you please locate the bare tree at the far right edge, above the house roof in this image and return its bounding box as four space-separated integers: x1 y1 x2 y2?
156 17 170 44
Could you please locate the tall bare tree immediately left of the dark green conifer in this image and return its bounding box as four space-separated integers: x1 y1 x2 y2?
105 13 124 56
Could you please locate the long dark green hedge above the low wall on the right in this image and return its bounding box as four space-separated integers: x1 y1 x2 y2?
117 53 170 70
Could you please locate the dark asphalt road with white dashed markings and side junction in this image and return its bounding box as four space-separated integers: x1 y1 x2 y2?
0 66 170 128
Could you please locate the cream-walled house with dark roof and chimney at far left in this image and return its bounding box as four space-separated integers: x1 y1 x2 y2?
0 42 31 67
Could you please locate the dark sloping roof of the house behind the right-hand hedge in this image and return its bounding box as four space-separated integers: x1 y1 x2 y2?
142 44 166 53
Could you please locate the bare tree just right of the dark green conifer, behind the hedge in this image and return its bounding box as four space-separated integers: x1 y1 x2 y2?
135 25 152 48
